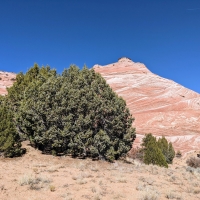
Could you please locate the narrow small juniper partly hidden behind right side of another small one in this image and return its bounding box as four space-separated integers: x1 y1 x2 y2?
158 136 175 164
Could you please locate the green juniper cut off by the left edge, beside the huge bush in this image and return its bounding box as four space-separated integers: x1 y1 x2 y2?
0 97 23 157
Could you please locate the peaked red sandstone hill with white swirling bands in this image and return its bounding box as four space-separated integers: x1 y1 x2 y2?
93 58 200 152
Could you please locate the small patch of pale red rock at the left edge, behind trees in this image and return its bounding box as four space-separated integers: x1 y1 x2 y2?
0 71 16 95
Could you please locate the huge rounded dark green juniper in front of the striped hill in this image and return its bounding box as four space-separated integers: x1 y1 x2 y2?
14 66 135 160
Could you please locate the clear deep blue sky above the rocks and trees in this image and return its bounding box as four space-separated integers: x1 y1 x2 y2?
0 0 200 93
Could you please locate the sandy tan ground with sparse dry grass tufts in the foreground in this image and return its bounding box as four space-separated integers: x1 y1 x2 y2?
0 142 200 200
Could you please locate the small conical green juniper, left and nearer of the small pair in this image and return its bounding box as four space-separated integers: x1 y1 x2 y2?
142 133 168 167
